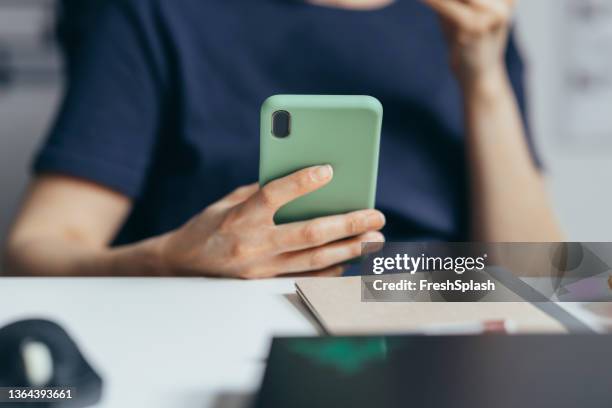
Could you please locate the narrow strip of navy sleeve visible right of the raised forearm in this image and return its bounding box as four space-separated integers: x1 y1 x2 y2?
506 31 543 169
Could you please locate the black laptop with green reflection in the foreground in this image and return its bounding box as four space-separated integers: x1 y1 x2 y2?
255 335 612 408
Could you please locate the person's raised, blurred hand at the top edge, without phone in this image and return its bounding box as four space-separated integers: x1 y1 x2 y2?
422 0 514 81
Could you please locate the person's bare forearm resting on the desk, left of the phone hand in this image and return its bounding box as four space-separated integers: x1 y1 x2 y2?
4 237 166 276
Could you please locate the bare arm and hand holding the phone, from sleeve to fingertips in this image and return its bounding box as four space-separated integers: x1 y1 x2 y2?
5 165 385 279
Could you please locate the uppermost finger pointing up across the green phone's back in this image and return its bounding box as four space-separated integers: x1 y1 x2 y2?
245 164 333 217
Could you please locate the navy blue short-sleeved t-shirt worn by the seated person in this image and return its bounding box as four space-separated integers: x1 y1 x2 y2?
35 0 524 243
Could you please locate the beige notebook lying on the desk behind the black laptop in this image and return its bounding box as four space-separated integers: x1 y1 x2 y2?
296 276 567 335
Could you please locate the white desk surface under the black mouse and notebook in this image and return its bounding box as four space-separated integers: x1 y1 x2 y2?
0 278 612 408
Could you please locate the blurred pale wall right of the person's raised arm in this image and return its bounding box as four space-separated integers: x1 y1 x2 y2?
517 0 612 241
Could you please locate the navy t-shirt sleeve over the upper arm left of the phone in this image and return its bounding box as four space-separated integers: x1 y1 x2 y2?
33 1 164 197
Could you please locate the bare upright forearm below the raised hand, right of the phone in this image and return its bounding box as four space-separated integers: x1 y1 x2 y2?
460 67 562 242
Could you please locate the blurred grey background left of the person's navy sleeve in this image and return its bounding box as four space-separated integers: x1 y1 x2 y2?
0 0 61 260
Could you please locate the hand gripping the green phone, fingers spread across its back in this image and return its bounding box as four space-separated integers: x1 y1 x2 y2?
160 165 385 279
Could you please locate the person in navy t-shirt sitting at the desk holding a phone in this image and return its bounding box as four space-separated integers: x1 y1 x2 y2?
6 0 561 278
